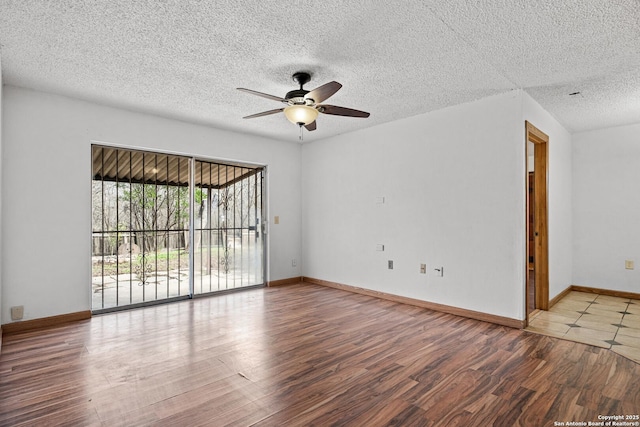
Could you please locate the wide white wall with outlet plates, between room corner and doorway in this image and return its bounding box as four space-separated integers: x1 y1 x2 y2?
302 91 525 319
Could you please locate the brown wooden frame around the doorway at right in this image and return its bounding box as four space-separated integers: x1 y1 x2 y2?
525 121 549 320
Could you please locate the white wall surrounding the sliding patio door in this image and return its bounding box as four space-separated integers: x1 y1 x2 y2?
1 86 301 323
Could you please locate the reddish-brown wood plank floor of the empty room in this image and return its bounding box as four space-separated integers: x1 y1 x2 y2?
0 284 640 426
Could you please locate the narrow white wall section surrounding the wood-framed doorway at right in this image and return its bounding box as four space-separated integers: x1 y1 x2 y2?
522 93 573 298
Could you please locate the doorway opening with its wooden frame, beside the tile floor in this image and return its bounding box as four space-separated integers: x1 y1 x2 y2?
525 121 549 322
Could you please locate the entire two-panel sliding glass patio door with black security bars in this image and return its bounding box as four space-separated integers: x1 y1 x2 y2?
91 145 264 312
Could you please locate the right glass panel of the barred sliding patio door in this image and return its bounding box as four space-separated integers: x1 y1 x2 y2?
194 161 264 294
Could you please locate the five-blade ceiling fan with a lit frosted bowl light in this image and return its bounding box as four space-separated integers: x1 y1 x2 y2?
237 72 369 135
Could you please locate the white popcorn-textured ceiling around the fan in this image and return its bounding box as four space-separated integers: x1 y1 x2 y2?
0 0 640 141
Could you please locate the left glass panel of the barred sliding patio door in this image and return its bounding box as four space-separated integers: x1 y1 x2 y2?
91 146 189 310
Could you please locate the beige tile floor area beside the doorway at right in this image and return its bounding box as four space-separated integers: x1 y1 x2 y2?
526 291 640 363
